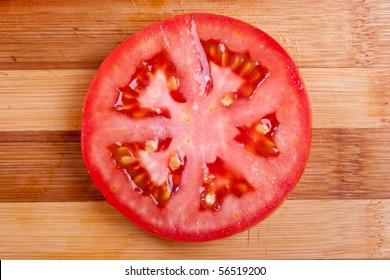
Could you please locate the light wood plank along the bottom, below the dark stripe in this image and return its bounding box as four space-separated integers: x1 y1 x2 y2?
0 200 390 259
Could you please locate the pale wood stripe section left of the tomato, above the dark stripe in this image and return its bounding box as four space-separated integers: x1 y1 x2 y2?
0 70 94 130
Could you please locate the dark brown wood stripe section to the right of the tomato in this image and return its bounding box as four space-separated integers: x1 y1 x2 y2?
291 128 390 199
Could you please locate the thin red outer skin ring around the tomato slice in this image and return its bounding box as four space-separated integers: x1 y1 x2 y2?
81 13 312 242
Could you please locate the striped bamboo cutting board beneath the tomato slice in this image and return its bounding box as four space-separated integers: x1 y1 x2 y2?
0 0 390 259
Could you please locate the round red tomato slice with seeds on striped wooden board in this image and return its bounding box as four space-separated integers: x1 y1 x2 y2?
81 14 311 241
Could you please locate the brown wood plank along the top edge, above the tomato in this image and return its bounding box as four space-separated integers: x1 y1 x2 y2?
0 0 390 70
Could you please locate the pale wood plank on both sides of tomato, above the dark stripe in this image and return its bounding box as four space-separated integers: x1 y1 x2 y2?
0 68 390 131
